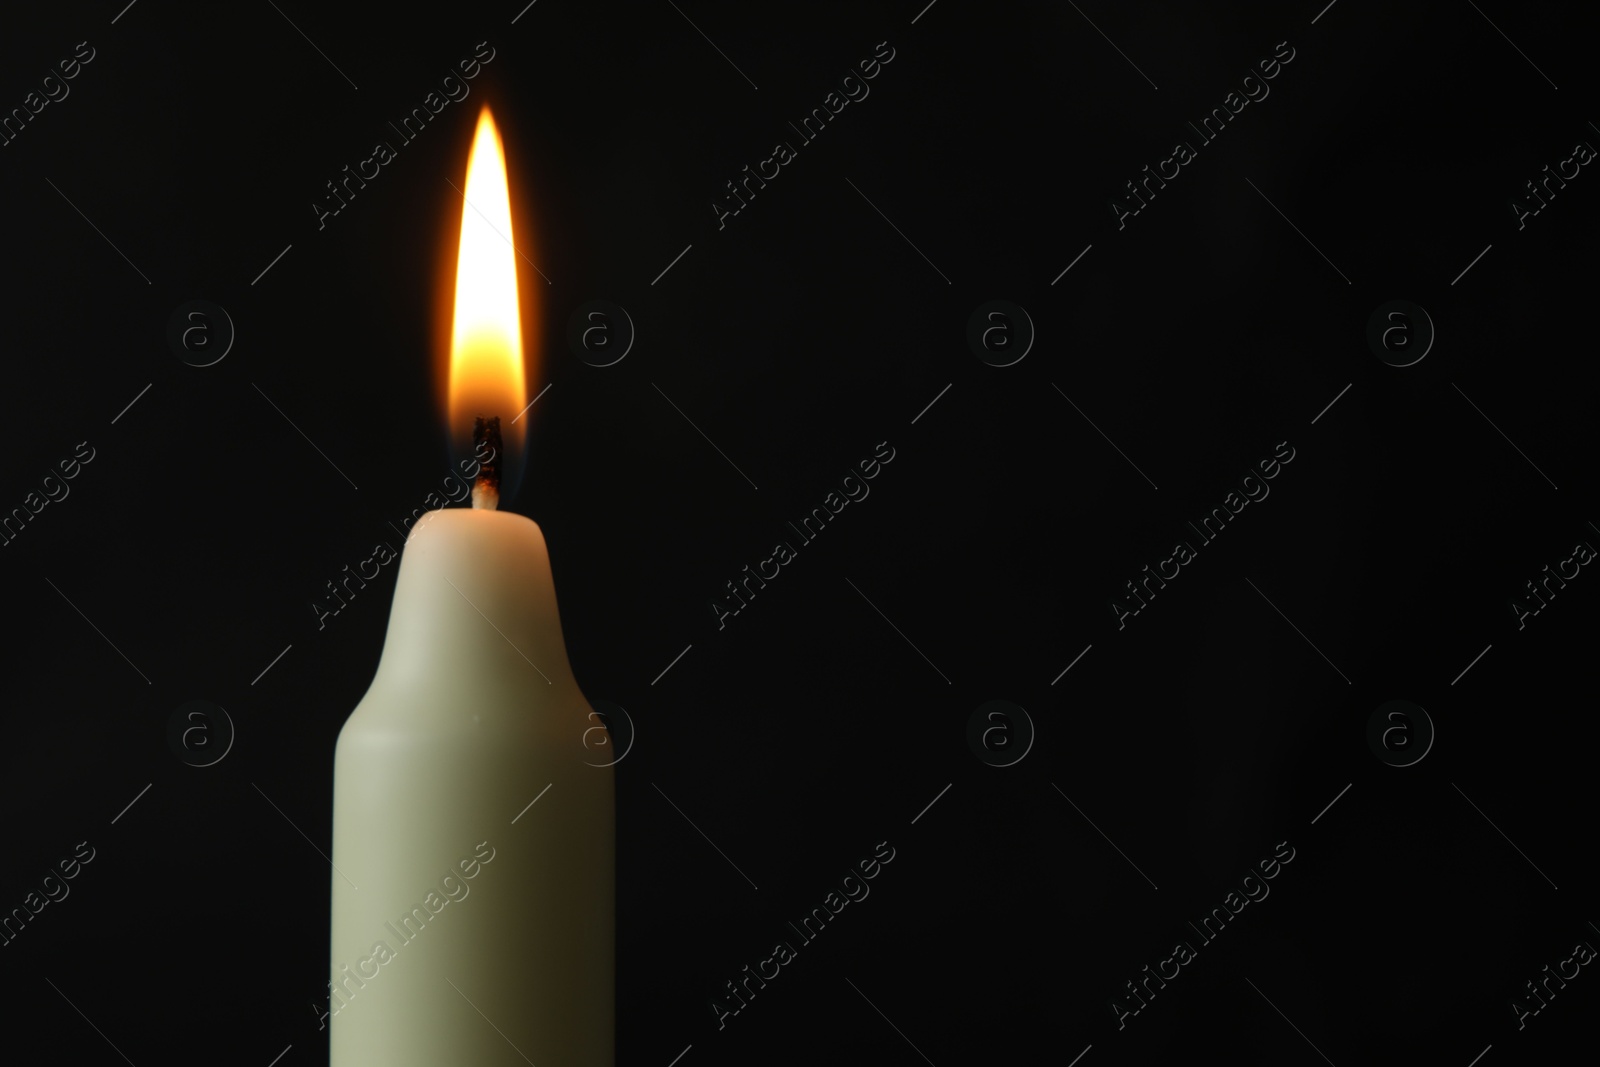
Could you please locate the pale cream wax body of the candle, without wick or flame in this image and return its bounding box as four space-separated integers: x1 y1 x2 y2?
330 509 614 1067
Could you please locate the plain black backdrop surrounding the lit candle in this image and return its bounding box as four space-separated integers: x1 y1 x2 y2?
0 0 1600 1067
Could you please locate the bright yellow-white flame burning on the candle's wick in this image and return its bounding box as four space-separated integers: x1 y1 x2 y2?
446 106 528 451
